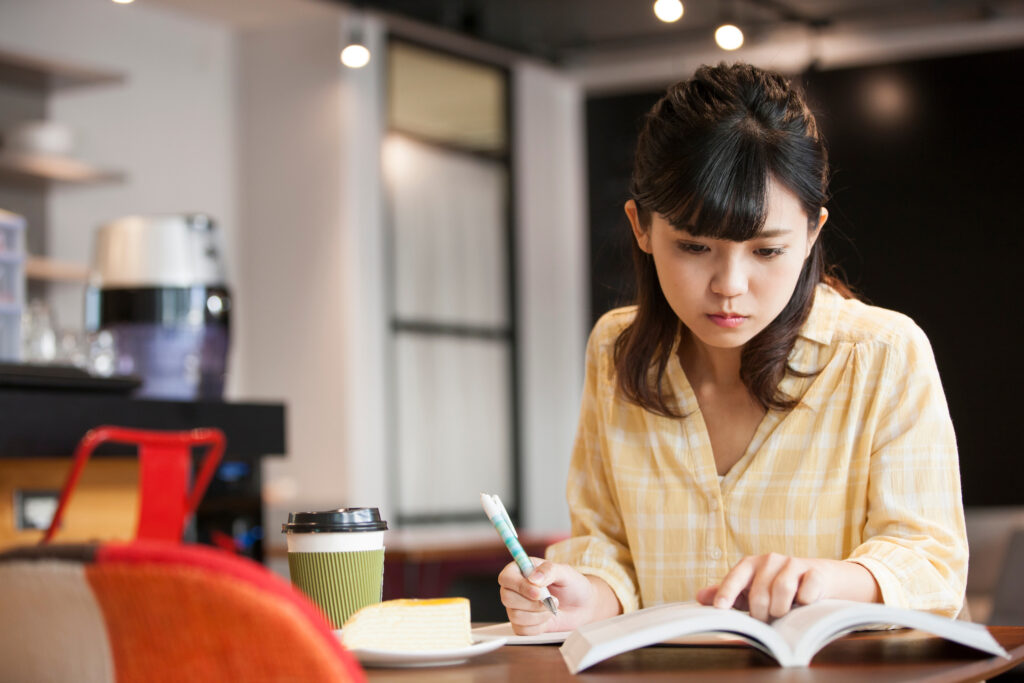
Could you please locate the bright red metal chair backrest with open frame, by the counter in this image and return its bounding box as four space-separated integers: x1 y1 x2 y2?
42 426 225 543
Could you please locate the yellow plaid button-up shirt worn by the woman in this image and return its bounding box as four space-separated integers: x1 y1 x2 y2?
547 285 968 616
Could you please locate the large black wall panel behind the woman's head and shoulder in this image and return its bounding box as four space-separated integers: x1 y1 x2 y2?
587 50 1024 505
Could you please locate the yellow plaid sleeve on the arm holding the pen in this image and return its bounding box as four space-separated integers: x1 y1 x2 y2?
546 321 639 612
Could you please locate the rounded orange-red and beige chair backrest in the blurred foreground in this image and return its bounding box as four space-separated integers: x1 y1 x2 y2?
0 542 365 683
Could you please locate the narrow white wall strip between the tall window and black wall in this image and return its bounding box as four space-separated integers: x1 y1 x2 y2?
512 62 590 531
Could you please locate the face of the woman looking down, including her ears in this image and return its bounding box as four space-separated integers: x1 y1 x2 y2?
626 182 828 348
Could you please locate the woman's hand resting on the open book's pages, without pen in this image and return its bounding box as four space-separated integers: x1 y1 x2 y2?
697 553 880 622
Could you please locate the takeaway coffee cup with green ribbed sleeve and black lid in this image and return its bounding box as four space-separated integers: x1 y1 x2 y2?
282 508 387 629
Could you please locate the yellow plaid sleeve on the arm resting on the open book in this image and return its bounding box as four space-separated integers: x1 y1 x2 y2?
848 325 968 616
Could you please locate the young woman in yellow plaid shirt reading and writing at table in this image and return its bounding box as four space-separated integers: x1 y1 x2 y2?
499 65 968 634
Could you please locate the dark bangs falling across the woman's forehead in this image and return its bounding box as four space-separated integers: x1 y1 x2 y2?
646 117 772 242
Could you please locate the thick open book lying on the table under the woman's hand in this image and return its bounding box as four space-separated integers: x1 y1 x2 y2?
560 600 1009 674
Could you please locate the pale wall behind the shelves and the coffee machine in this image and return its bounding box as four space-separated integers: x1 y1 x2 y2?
0 0 238 339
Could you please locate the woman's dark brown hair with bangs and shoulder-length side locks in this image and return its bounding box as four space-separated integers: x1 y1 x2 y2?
614 63 852 417
